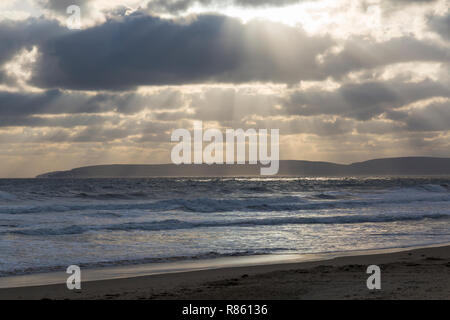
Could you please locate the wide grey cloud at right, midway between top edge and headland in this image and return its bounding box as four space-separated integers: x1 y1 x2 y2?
283 80 450 120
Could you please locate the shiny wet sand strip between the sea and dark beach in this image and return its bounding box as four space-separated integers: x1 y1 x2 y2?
0 242 450 290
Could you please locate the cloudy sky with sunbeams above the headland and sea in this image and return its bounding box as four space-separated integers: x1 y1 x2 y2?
0 0 450 178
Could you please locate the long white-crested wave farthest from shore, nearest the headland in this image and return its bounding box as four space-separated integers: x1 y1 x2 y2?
0 190 450 214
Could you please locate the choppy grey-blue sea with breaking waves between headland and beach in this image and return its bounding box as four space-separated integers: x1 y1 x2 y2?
0 177 450 277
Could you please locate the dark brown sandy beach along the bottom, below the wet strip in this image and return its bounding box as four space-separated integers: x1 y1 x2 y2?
0 245 450 300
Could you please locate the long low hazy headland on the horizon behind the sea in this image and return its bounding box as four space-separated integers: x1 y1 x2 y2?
36 157 450 178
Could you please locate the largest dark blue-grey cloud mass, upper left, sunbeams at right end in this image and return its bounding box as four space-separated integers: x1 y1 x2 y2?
32 15 333 90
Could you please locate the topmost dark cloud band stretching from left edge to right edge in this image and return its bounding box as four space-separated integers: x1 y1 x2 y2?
0 14 449 90
